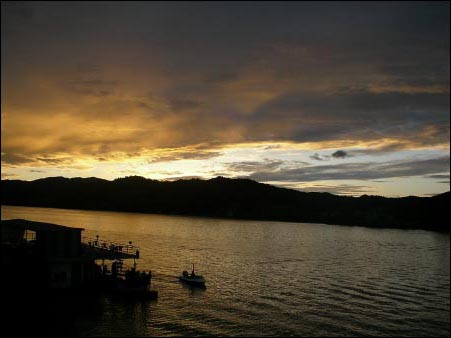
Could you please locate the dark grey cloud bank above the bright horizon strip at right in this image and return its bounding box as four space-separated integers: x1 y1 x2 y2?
249 92 450 144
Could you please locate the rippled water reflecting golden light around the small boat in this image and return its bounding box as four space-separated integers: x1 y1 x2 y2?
1 206 450 336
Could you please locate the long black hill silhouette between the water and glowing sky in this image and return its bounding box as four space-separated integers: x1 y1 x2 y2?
1 176 450 231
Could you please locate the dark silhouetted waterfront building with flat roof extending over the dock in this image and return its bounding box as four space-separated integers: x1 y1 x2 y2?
1 219 139 289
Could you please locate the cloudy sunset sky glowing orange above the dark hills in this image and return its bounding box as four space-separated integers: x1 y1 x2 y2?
1 1 450 197
